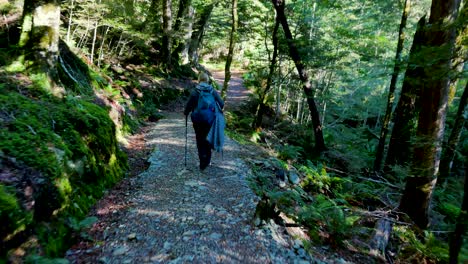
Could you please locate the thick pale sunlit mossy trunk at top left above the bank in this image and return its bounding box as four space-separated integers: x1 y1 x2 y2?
19 0 63 95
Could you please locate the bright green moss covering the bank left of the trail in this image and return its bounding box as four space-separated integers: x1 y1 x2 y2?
0 83 127 257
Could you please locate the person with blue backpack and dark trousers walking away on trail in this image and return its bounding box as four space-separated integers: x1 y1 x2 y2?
184 72 224 171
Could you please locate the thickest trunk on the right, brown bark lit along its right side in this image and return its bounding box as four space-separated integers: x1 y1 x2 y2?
400 0 460 229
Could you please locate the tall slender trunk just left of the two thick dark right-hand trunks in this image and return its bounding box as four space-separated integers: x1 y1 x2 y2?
374 0 411 172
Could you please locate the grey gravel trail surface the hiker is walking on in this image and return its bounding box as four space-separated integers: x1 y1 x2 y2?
66 71 311 263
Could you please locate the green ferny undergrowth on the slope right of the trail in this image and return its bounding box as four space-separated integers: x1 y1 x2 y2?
226 85 468 263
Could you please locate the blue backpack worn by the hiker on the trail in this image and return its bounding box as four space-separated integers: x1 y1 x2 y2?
192 83 216 125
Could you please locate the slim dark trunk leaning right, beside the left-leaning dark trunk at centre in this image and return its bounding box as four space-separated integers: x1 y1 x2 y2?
253 17 279 129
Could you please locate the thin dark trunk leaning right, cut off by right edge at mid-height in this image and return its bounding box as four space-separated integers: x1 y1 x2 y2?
438 82 468 182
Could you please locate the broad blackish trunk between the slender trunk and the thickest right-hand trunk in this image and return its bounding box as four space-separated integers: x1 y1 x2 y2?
385 17 426 170
